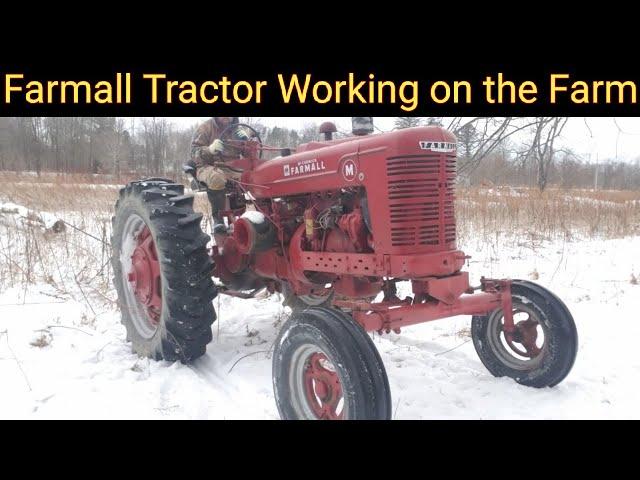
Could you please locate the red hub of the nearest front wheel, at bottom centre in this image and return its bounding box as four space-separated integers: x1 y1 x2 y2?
304 353 344 420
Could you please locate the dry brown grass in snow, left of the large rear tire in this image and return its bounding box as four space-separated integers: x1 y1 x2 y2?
0 174 118 304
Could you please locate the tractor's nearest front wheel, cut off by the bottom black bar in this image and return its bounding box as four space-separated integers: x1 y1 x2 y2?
273 307 391 420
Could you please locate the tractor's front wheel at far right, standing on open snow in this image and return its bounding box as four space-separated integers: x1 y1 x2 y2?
471 280 578 388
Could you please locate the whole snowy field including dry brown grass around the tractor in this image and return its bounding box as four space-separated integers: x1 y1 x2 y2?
0 174 640 419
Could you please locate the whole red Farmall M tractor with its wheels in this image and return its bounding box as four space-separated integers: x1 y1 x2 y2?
112 121 578 419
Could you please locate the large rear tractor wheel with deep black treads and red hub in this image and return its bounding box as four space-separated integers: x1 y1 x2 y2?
111 178 217 363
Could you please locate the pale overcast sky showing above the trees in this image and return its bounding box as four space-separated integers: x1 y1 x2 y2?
160 117 640 162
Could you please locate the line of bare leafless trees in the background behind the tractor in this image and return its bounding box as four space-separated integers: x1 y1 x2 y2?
5 117 640 190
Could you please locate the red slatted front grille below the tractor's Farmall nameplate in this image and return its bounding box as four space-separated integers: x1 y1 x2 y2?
387 154 456 247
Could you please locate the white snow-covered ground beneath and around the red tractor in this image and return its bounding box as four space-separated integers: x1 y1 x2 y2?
0 197 640 419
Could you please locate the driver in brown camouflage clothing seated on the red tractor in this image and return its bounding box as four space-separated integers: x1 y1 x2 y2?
191 117 249 232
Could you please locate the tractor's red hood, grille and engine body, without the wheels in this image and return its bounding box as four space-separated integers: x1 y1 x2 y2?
214 127 468 300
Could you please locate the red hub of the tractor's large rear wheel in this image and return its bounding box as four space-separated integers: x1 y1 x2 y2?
128 226 162 327
